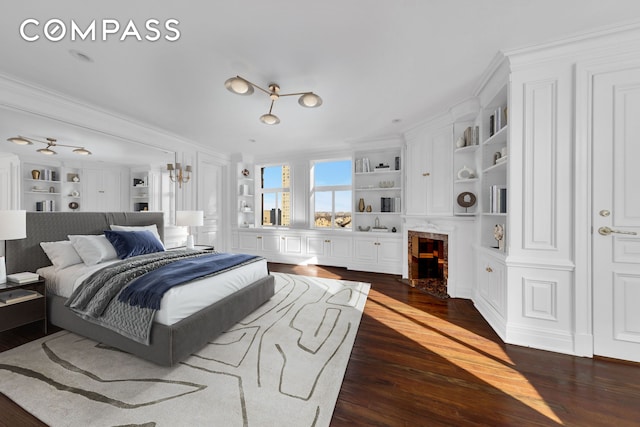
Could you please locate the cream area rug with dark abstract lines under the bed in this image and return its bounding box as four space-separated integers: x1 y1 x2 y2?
0 273 370 427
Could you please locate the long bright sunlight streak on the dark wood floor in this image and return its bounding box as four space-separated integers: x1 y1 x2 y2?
365 290 562 424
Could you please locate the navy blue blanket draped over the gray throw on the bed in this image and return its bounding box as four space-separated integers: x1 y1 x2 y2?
118 253 259 310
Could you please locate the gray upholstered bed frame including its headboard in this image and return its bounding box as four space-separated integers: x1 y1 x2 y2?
5 212 274 366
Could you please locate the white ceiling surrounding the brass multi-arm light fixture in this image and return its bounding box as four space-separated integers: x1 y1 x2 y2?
0 0 640 157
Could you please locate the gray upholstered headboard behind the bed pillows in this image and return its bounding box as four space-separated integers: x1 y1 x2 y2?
5 212 164 274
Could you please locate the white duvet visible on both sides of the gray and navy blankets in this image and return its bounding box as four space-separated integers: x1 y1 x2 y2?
37 259 269 325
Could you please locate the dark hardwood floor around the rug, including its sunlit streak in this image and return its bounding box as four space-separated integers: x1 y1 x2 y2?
0 263 640 427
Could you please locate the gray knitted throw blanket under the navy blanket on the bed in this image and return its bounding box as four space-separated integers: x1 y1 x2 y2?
65 250 258 345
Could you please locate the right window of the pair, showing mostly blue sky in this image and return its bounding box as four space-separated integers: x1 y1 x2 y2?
311 160 352 229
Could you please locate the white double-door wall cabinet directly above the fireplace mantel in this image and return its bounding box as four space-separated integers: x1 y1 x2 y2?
405 124 453 216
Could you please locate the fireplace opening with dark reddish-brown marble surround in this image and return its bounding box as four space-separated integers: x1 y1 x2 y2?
408 230 449 298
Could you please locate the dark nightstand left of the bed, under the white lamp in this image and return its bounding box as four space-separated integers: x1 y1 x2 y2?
0 277 47 334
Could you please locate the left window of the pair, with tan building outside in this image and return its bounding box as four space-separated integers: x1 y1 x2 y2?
260 165 291 226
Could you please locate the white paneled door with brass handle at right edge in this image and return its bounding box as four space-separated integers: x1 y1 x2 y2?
592 68 640 362
